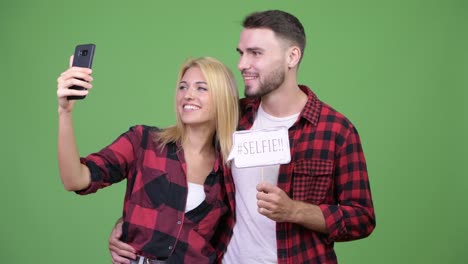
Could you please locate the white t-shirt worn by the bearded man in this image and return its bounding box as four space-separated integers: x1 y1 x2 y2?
223 105 299 264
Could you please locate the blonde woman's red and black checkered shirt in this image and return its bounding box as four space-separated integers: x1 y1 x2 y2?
78 126 232 263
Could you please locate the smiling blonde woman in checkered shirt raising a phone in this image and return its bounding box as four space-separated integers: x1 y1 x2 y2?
57 57 239 263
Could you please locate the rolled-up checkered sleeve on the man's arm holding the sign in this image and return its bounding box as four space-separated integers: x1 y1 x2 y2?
320 127 376 241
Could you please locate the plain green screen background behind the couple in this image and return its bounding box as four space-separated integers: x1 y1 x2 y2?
0 0 468 264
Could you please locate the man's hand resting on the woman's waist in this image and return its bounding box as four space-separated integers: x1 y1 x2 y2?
109 218 136 264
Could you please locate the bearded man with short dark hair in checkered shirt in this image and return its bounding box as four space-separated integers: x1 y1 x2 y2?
110 10 375 264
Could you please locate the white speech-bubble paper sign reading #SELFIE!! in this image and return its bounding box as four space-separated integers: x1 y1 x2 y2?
228 127 291 168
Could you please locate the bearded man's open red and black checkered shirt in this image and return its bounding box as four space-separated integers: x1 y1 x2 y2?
220 86 375 264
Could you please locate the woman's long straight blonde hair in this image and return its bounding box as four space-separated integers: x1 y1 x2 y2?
155 57 239 163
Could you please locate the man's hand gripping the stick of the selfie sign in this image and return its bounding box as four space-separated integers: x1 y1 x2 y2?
257 182 294 222
